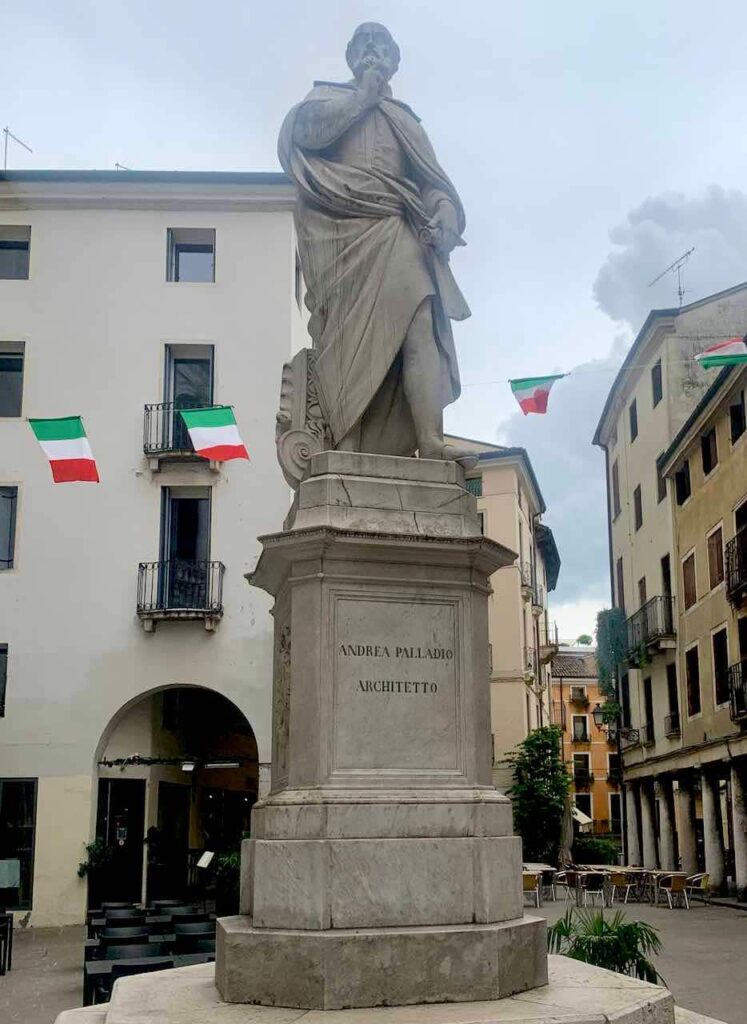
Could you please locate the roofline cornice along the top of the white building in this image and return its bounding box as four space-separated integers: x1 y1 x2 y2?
0 171 295 212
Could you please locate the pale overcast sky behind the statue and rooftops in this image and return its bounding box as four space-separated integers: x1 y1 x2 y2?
5 0 747 636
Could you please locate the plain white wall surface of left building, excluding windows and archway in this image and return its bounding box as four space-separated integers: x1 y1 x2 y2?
0 186 303 924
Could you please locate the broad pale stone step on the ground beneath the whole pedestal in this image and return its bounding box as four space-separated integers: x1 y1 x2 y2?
56 956 722 1024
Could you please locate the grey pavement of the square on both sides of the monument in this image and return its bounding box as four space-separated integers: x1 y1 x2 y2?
0 902 747 1024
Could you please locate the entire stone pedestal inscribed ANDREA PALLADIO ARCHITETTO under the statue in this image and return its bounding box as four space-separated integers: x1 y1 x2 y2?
216 452 546 1010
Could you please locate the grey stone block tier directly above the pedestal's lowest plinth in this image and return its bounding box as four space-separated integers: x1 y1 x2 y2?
250 836 523 929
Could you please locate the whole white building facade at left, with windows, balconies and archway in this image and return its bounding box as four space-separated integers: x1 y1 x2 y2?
0 172 306 926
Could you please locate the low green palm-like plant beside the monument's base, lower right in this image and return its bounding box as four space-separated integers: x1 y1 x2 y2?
547 909 661 984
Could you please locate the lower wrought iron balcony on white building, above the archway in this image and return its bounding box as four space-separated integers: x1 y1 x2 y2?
137 558 225 633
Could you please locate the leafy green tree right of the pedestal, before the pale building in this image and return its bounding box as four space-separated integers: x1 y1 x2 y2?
508 725 570 864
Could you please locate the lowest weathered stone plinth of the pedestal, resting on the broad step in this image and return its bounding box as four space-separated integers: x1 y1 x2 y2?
215 918 547 1010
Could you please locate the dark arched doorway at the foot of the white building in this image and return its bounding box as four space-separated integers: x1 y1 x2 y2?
88 686 258 906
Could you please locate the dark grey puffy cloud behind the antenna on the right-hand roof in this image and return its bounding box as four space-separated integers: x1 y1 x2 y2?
593 185 747 331
